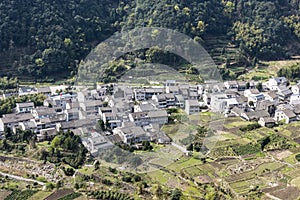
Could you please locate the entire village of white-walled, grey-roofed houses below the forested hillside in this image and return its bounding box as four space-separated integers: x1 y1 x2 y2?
0 77 300 154
